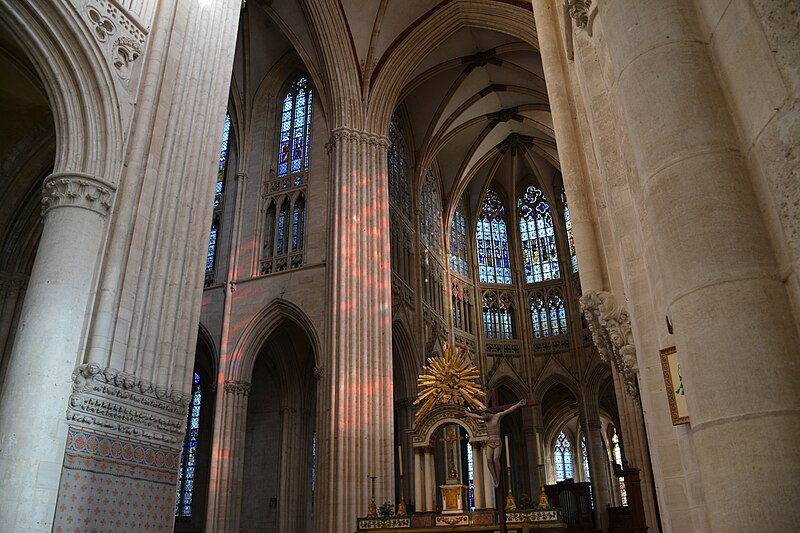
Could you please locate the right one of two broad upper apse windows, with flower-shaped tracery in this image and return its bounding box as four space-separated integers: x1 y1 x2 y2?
518 185 560 283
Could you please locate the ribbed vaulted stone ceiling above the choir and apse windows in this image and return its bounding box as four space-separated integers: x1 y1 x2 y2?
241 0 560 222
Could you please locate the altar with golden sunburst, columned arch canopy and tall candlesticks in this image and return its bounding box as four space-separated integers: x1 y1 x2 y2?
357 344 566 533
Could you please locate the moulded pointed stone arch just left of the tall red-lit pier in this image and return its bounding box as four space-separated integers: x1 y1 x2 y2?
227 298 320 381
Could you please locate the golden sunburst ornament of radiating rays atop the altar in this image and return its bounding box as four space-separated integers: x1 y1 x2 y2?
414 343 486 418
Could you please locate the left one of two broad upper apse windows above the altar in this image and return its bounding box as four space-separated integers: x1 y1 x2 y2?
475 189 511 285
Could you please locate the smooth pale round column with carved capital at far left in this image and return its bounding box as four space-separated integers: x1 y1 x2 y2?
0 173 114 531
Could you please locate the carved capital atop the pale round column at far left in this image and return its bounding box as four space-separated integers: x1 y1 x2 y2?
42 172 116 216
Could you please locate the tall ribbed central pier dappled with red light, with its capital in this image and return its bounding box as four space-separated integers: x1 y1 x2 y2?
315 128 395 532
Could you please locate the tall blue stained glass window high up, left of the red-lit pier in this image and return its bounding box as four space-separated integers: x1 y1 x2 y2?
278 77 312 177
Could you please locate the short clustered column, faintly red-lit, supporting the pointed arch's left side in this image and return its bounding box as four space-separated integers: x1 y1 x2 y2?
206 381 250 533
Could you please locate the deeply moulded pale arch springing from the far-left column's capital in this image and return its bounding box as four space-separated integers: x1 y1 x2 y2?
0 0 125 180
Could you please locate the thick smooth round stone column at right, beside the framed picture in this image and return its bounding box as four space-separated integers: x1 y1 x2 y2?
595 0 800 531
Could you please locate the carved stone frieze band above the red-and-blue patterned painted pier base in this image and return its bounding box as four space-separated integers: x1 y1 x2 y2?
67 363 191 445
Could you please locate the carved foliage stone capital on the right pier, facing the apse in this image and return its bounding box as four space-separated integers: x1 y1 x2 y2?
580 291 639 403
